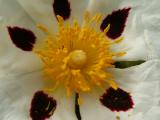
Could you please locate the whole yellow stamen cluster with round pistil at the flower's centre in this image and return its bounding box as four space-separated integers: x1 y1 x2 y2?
34 14 124 96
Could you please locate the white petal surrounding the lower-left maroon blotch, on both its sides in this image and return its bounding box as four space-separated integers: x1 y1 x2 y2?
0 71 76 120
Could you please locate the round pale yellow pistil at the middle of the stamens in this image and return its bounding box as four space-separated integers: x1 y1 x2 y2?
68 50 87 69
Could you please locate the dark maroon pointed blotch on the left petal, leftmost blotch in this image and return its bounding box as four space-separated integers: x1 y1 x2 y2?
8 27 36 51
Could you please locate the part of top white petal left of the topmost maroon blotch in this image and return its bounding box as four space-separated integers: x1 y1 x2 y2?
17 0 57 31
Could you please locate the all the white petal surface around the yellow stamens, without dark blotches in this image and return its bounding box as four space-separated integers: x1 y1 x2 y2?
0 0 160 120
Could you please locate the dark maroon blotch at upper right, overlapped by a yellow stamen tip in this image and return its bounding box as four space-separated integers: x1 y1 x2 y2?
100 8 131 39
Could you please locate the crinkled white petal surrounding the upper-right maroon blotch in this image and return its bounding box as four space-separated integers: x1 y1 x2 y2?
88 0 160 60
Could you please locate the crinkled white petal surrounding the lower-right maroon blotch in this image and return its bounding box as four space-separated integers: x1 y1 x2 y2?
80 60 160 120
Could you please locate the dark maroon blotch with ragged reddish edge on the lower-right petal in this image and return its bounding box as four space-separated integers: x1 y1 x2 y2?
100 88 134 111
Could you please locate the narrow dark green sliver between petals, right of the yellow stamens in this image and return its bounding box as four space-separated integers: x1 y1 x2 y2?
114 60 145 69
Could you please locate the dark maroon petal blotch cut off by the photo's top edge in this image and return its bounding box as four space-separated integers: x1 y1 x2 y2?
53 0 71 20
